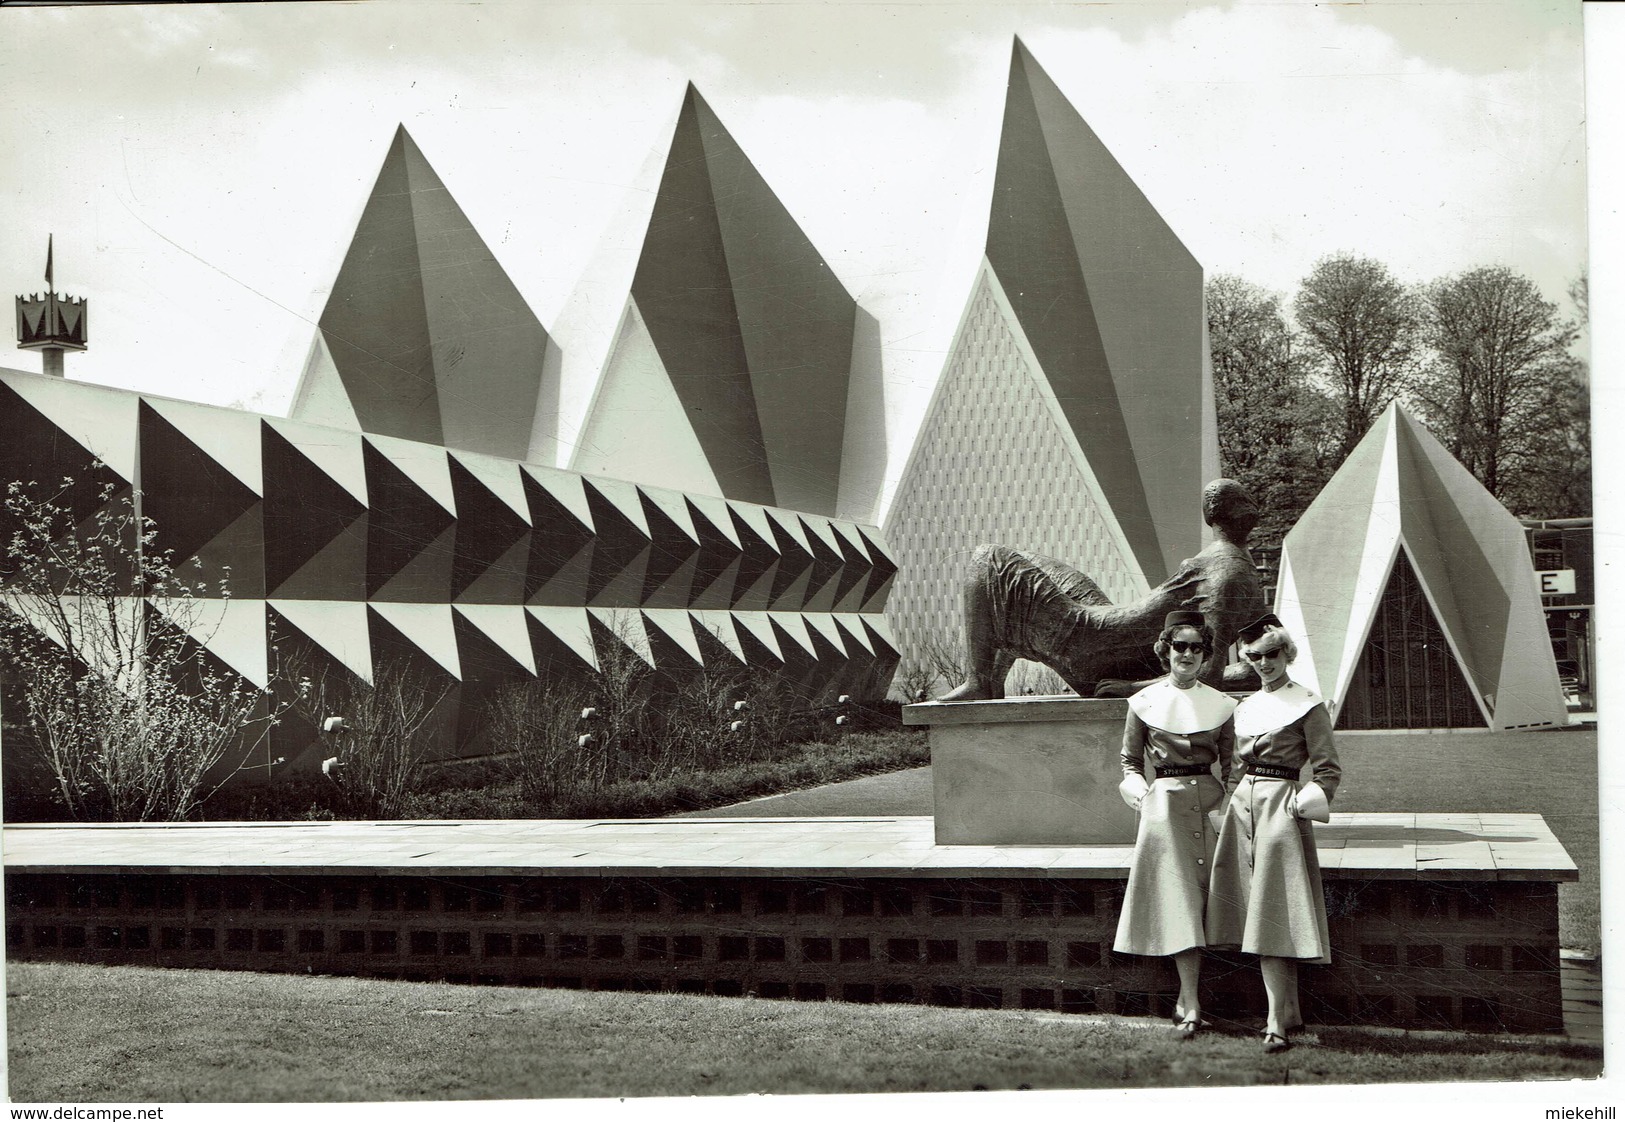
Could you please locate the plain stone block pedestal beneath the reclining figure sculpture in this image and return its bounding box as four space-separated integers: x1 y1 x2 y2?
904 698 1138 846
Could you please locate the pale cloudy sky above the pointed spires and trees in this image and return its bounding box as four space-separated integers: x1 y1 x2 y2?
0 0 1586 500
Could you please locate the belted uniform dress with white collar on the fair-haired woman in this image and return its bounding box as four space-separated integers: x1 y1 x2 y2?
1207 681 1342 963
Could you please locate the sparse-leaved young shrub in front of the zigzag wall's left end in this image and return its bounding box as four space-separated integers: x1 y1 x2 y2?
0 465 292 821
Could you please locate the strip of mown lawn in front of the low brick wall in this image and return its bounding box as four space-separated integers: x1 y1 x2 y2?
7 963 1602 1102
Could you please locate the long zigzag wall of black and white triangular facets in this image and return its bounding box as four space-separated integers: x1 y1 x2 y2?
0 371 897 767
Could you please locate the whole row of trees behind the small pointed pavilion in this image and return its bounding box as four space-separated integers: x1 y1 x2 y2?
1206 260 1591 526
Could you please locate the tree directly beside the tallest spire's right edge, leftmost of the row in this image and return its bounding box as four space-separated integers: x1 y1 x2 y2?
1206 276 1341 546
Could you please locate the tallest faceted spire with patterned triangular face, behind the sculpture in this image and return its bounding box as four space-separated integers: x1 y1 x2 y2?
886 39 1219 673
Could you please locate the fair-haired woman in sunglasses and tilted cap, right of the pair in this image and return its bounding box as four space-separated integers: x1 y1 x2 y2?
1207 615 1342 1052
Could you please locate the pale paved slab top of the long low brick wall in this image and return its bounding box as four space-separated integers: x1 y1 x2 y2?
3 813 1580 881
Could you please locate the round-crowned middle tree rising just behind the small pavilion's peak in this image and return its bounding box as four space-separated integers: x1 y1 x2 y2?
1292 252 1422 467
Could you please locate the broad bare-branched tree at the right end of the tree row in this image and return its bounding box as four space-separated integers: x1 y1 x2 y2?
1417 265 1589 515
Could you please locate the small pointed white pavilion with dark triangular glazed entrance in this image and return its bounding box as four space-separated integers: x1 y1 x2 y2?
1276 403 1568 732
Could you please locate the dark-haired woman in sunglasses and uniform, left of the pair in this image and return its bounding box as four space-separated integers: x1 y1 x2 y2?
1113 611 1235 1039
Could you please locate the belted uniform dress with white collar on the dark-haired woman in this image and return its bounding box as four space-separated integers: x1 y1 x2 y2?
1113 680 1235 955
